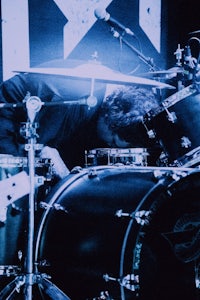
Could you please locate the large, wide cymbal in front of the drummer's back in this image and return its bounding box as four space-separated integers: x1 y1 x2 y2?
13 63 175 89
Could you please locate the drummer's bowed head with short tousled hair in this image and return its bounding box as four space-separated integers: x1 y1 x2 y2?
100 86 158 147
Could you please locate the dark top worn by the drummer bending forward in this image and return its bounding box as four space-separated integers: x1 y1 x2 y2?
0 69 105 167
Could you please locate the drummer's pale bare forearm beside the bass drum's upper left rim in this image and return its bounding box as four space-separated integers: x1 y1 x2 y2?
40 146 70 179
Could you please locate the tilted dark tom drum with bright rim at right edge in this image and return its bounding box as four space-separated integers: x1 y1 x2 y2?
144 86 200 166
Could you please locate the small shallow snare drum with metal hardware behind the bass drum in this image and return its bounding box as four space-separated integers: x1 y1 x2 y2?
85 148 149 167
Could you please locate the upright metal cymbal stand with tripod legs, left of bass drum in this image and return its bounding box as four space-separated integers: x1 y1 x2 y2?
0 97 70 300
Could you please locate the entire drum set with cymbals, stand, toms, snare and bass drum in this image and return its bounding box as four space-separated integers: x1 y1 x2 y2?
0 42 200 300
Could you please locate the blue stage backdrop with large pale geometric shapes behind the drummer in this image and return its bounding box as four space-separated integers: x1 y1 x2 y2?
0 0 199 80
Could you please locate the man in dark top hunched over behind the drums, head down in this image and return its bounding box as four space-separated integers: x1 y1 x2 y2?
0 69 161 178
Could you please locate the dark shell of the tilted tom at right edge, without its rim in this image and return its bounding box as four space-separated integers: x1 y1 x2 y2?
146 93 200 165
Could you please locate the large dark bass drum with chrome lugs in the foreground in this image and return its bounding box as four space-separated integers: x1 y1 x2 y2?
35 166 200 300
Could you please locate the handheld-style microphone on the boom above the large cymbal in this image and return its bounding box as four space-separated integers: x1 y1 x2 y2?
94 8 135 36
